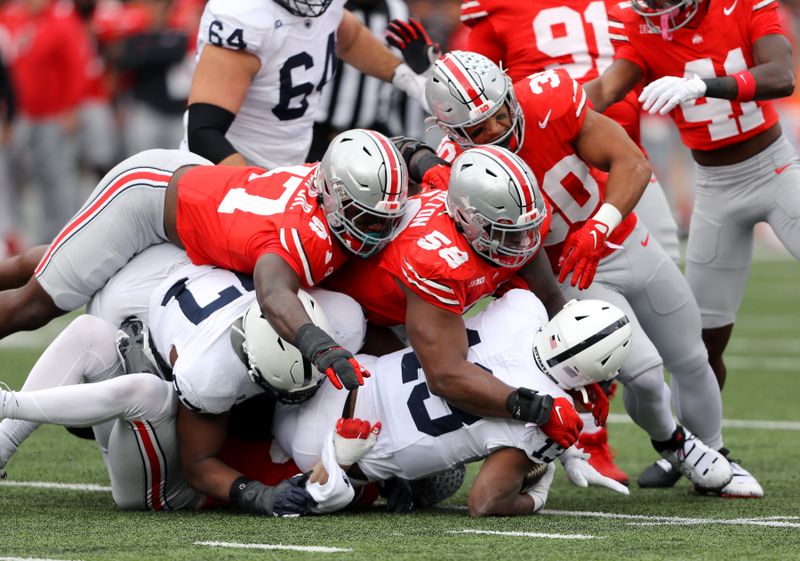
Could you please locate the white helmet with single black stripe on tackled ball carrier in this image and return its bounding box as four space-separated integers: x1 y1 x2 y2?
533 300 633 390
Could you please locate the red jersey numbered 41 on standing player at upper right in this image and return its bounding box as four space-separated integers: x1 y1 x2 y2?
609 0 783 150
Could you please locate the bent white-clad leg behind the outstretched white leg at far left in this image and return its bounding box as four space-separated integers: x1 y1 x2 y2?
0 316 122 469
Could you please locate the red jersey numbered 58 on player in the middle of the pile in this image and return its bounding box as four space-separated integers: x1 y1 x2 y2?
325 190 536 326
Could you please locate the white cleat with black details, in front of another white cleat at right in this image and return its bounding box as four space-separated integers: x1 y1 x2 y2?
662 429 733 492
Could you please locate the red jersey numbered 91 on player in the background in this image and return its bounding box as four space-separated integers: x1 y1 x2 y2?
461 0 641 143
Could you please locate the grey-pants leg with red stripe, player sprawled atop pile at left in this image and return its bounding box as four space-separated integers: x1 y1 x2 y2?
0 150 206 337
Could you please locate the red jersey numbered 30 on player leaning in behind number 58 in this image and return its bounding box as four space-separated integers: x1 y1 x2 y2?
438 69 636 271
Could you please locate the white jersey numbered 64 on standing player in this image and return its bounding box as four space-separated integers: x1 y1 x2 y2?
191 0 345 169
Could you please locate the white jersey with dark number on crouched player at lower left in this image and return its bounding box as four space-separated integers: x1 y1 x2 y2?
150 264 264 413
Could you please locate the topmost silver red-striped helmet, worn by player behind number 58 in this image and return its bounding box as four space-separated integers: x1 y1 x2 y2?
425 51 525 152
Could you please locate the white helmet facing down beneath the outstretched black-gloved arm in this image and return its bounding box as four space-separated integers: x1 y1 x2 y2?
242 290 333 403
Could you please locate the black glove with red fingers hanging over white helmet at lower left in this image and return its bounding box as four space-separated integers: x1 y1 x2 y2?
294 323 369 390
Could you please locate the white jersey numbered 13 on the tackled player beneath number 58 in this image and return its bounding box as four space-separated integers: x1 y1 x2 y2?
275 290 569 480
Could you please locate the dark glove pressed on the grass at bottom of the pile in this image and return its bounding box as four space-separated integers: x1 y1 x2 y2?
230 473 316 516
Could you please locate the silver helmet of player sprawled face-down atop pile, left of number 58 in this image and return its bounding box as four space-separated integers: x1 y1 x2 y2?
311 129 408 257
